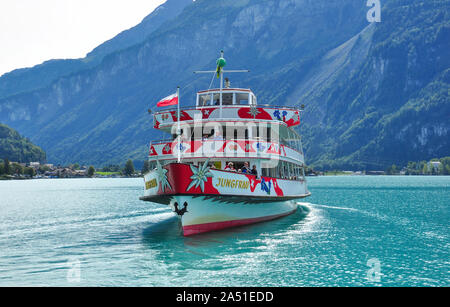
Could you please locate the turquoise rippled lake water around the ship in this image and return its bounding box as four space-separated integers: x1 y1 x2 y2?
0 176 450 286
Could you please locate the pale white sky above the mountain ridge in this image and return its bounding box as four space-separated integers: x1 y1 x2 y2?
0 0 165 76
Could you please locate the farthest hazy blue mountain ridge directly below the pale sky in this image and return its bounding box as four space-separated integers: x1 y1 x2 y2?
0 0 192 98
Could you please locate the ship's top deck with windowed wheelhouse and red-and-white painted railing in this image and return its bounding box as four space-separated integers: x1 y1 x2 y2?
153 88 300 130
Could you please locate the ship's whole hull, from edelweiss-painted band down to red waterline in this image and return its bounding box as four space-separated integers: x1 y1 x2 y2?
141 163 310 236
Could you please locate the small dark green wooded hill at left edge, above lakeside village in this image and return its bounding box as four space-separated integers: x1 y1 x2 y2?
0 124 45 163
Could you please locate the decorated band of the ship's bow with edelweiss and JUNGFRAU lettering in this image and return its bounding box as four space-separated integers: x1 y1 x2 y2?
141 161 309 204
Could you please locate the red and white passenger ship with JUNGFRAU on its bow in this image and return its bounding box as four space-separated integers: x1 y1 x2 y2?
140 53 310 236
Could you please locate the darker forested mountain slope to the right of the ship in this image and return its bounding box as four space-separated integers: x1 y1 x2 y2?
302 0 450 169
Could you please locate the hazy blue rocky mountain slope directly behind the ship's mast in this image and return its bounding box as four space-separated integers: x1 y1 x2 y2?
0 0 367 168
